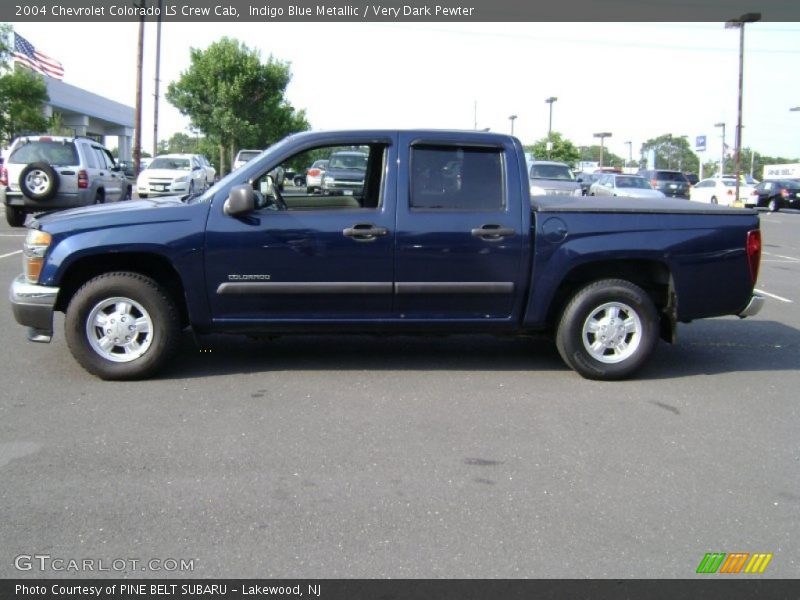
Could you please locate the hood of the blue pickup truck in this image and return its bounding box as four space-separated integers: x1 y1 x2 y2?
30 196 209 234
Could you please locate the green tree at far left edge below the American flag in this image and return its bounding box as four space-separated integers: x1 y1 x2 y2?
0 24 49 145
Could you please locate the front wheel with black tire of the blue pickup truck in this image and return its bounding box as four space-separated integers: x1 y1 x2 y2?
64 271 181 381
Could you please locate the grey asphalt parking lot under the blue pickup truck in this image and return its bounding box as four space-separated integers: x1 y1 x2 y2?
0 206 800 578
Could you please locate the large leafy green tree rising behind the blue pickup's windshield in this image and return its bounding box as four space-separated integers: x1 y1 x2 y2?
167 37 309 174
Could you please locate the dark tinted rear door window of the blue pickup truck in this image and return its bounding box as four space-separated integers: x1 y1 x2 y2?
410 146 504 210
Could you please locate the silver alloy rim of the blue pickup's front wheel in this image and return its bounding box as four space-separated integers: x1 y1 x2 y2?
86 297 153 363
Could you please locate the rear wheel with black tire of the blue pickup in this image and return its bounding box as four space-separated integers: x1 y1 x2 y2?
556 279 659 381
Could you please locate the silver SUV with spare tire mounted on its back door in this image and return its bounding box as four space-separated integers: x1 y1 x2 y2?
0 135 131 227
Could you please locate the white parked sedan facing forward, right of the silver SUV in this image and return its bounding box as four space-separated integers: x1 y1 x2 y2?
136 154 206 198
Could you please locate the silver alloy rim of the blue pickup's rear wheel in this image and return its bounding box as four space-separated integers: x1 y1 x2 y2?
581 302 642 364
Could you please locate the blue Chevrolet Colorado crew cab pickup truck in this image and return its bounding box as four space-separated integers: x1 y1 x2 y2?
10 130 763 379
